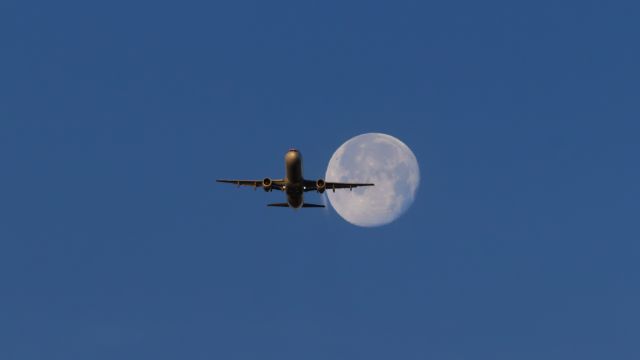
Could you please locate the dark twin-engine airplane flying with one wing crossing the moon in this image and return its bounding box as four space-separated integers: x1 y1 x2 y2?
216 149 374 209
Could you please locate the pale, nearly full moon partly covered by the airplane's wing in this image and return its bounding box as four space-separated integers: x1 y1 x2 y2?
325 133 420 227
